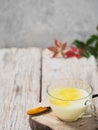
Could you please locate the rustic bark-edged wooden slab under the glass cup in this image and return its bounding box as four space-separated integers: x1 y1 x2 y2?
29 109 98 130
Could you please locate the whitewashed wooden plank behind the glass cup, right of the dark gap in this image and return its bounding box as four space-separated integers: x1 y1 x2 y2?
42 49 98 104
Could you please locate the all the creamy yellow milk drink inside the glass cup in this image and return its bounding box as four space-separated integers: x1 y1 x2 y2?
50 87 88 121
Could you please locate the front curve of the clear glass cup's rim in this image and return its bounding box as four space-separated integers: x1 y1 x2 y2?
46 82 93 101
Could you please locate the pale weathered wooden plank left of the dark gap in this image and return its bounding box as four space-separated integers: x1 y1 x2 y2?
0 48 41 130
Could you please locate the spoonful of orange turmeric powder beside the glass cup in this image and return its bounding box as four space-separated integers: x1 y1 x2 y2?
27 107 50 115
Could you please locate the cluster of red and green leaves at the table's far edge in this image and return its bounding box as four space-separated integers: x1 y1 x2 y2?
48 26 98 59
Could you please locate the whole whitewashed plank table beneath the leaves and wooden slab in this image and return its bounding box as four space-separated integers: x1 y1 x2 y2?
0 48 98 130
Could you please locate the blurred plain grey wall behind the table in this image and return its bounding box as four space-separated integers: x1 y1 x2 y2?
0 0 98 48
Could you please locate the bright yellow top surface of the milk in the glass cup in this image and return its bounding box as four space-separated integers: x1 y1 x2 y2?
50 87 88 106
